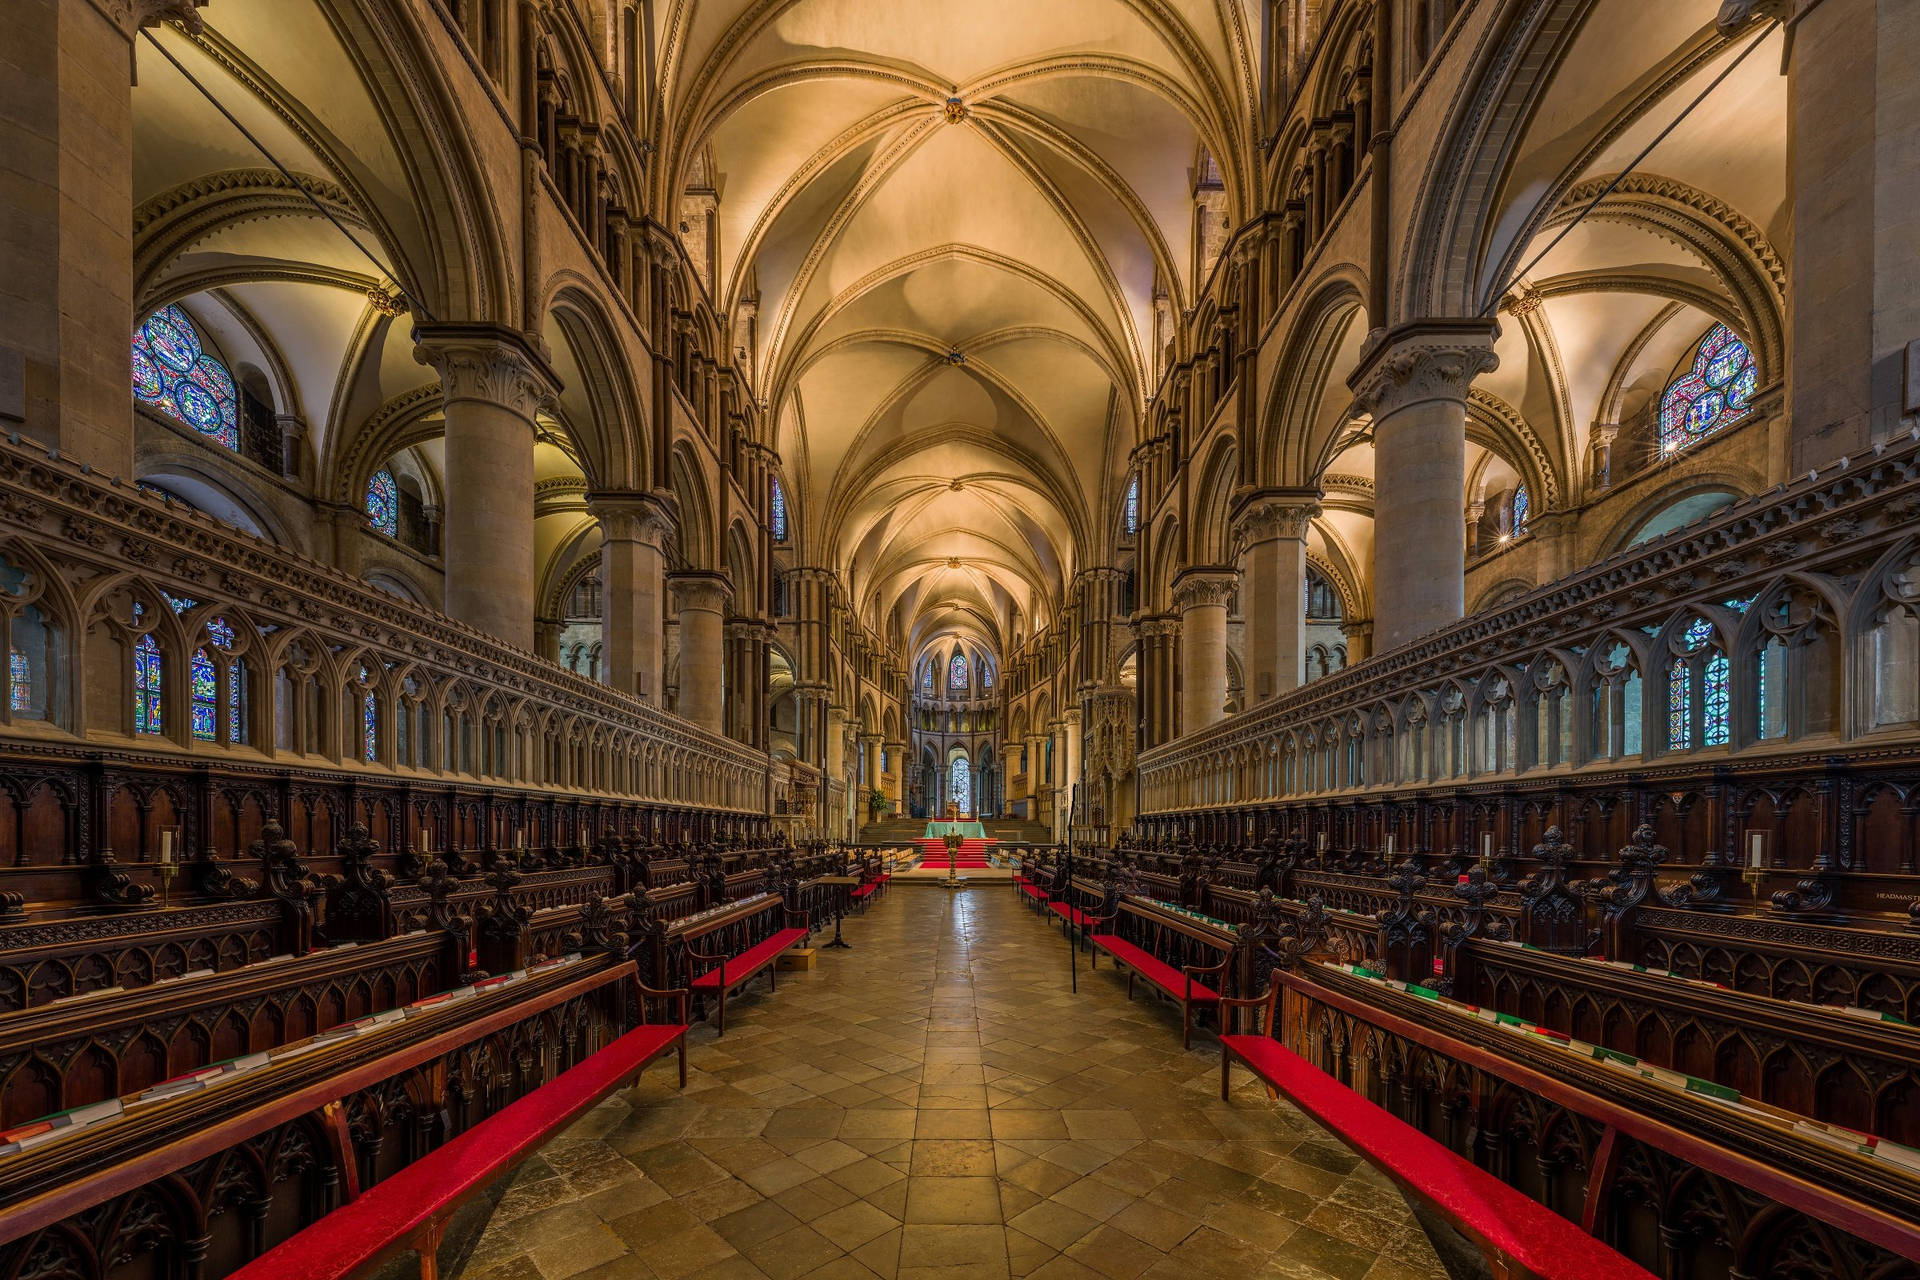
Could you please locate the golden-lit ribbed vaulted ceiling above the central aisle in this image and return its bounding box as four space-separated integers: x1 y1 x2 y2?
657 0 1252 652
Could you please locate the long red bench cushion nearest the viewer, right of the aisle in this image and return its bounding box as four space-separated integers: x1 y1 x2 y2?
1219 1036 1653 1280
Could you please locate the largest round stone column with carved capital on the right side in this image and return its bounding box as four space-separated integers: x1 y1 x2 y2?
1348 319 1500 651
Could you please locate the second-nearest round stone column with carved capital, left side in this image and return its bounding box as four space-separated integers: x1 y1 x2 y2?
588 493 674 704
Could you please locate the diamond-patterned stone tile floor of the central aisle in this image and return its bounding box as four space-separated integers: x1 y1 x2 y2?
459 887 1446 1280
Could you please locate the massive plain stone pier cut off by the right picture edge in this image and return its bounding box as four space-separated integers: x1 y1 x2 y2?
1781 0 1920 474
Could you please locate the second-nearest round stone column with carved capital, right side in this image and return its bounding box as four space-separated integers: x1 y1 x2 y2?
1235 489 1319 706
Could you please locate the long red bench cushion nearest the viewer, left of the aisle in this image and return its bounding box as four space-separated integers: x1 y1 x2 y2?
228 1027 687 1280
